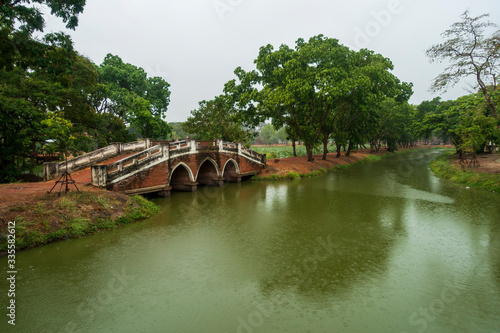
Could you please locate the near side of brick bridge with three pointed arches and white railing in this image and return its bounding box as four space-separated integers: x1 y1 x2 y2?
92 140 266 196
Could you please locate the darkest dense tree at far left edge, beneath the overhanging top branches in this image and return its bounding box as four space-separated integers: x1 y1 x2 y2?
0 35 96 181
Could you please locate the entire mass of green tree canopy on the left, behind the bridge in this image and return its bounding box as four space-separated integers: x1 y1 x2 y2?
0 0 170 182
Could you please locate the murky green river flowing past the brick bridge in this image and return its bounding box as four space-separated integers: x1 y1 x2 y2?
0 151 500 333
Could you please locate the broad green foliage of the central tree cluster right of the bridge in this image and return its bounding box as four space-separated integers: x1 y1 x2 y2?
207 35 412 161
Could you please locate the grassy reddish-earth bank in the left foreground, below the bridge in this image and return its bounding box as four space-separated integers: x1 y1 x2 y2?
0 192 159 254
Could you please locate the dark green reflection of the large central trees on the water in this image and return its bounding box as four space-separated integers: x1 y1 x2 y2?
260 188 406 301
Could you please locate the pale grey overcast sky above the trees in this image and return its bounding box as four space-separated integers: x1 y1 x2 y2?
45 0 500 122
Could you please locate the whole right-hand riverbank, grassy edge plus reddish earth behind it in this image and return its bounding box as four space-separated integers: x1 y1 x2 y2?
431 152 500 193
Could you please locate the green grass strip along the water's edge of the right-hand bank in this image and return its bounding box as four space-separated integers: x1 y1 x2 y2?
431 152 500 192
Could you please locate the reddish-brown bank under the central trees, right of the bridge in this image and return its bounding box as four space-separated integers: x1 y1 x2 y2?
253 146 443 180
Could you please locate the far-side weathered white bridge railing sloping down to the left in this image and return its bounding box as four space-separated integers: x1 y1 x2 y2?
43 139 151 180
